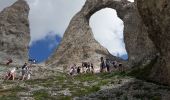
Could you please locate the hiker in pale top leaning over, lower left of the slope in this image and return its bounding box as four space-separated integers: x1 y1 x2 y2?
5 67 16 80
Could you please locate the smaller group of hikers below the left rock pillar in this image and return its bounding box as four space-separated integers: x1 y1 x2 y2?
4 59 36 80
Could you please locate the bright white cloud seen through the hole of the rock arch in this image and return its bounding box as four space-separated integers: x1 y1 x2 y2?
90 8 127 56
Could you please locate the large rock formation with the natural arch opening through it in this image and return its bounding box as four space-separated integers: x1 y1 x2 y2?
46 0 156 67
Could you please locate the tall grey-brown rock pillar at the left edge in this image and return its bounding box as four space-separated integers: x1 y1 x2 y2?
0 0 30 64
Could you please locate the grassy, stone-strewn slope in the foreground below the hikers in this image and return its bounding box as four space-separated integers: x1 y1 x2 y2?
0 72 170 100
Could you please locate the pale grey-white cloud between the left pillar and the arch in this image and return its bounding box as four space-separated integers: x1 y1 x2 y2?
27 0 85 43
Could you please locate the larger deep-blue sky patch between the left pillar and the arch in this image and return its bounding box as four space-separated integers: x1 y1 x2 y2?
29 32 62 62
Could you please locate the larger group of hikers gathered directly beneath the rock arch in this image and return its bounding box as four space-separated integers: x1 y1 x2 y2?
69 57 124 75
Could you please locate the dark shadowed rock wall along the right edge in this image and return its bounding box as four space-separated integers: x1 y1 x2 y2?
137 0 170 84
